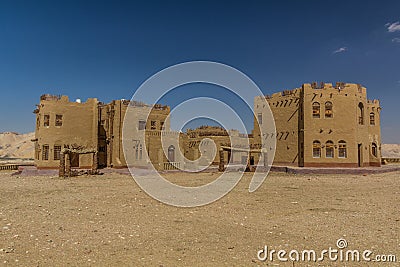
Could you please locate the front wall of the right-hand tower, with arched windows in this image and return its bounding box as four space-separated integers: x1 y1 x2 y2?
303 83 381 167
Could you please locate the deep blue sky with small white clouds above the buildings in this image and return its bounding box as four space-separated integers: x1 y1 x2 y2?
0 0 400 143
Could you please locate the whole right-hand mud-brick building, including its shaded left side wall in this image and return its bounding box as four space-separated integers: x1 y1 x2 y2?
254 83 381 167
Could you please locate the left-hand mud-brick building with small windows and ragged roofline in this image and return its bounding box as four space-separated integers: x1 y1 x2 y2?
33 95 170 169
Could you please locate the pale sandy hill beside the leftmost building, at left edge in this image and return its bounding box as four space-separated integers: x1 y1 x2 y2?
0 132 35 159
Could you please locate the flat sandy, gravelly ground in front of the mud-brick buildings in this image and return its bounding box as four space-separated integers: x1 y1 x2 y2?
0 172 400 266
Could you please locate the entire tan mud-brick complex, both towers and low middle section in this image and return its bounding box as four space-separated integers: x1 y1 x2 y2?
35 83 381 170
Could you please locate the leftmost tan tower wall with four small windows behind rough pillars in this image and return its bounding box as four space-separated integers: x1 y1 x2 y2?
34 95 98 169
